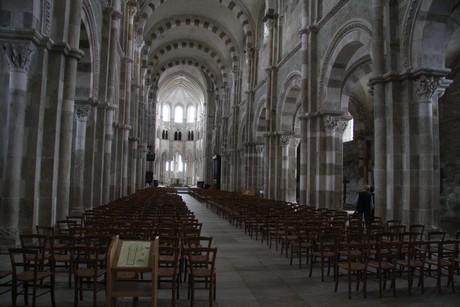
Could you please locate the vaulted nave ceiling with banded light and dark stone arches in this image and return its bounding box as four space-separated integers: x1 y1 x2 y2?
135 0 265 93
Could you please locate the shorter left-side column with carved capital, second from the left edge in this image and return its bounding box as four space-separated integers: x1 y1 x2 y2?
70 104 91 215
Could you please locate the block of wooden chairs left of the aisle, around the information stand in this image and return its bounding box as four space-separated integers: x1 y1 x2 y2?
0 189 217 306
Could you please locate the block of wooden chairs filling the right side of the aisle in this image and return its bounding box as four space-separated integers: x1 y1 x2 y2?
192 189 460 296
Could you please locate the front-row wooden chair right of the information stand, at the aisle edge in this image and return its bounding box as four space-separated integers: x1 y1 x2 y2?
187 247 217 307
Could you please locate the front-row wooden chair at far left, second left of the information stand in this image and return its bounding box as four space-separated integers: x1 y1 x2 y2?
8 248 56 307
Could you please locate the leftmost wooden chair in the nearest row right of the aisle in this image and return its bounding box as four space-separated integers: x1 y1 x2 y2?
335 243 369 299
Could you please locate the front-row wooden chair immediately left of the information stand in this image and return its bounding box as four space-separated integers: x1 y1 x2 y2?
72 245 107 307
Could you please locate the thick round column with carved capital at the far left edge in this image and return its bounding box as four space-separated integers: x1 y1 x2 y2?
0 42 34 245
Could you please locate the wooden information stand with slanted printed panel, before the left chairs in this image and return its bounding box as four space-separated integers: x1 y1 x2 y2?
106 236 159 307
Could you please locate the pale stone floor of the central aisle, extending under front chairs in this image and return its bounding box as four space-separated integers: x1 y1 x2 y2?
0 194 460 307
